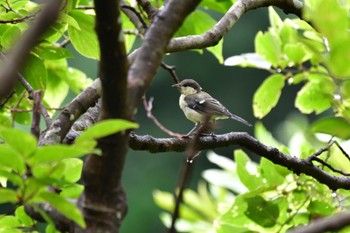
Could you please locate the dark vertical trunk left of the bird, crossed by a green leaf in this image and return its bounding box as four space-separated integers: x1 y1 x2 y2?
78 0 128 232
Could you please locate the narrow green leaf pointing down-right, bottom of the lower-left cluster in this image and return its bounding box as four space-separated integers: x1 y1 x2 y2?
40 192 85 228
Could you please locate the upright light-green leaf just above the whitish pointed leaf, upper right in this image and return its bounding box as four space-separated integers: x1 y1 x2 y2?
254 32 282 67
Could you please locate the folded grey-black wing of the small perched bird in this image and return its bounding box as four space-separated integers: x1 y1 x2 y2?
185 92 231 117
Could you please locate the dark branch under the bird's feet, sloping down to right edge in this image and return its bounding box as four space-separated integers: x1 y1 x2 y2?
130 132 350 190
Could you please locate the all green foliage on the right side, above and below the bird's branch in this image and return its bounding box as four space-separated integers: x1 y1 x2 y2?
154 0 350 233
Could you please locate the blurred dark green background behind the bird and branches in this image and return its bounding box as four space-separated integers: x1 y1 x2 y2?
69 8 297 232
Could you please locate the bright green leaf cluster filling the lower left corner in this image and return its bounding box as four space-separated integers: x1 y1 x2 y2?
0 119 137 232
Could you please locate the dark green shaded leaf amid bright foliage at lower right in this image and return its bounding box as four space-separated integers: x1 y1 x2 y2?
245 196 279 227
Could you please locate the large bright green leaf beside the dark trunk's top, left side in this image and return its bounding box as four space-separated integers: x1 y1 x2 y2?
68 10 100 60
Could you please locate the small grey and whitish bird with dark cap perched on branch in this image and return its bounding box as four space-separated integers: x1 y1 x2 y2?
172 79 252 134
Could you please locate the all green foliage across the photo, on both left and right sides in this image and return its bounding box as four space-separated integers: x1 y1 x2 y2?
0 0 350 233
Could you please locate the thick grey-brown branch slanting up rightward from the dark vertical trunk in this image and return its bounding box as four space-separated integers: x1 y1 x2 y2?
128 0 200 115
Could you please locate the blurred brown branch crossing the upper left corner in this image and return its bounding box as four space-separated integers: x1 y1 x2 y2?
0 0 62 98
